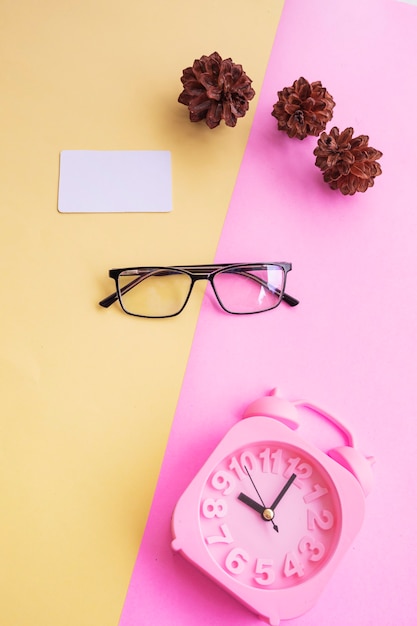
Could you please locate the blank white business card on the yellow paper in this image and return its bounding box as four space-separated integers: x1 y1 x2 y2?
58 150 172 213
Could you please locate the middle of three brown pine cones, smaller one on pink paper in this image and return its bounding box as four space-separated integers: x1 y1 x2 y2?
271 76 335 139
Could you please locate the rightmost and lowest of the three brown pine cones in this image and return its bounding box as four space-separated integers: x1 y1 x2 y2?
314 126 382 196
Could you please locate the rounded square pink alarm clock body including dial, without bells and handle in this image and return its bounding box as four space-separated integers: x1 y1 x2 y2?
172 416 365 625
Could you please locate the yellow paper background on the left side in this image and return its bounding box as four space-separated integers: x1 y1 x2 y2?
0 0 283 626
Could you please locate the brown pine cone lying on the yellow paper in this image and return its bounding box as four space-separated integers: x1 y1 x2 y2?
178 52 255 128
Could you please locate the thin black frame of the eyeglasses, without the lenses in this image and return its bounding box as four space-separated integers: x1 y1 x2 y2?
99 261 299 319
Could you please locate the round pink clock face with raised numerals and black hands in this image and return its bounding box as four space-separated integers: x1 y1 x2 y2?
199 441 341 589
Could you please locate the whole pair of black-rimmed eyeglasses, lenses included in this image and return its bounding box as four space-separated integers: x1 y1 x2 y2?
99 263 299 318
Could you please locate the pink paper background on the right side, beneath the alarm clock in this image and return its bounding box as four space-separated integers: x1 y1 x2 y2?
120 0 417 626
